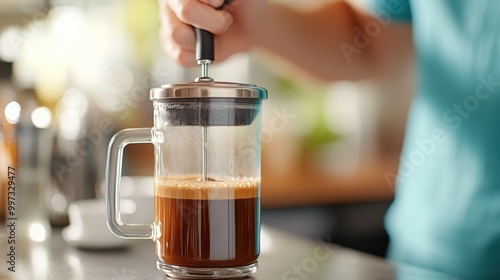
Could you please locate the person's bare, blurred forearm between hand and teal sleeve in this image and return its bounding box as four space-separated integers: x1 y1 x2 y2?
255 1 411 81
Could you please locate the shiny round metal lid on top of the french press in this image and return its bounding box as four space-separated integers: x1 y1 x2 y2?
150 80 267 100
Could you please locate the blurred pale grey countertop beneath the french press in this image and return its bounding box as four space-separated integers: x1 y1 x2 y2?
0 225 457 280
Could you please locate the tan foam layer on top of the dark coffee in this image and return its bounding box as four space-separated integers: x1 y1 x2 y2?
155 178 260 200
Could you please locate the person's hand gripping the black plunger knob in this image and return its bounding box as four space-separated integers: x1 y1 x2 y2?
158 0 265 66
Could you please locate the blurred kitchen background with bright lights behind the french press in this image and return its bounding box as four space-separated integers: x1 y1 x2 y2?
0 0 412 256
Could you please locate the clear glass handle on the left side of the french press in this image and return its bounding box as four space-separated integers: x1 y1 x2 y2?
105 128 154 239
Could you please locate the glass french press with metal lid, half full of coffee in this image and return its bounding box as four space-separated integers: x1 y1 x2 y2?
106 1 267 278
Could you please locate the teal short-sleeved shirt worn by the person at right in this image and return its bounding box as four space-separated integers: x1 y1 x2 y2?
366 0 500 279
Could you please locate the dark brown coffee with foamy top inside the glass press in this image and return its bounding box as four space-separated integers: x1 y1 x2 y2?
155 180 260 267
